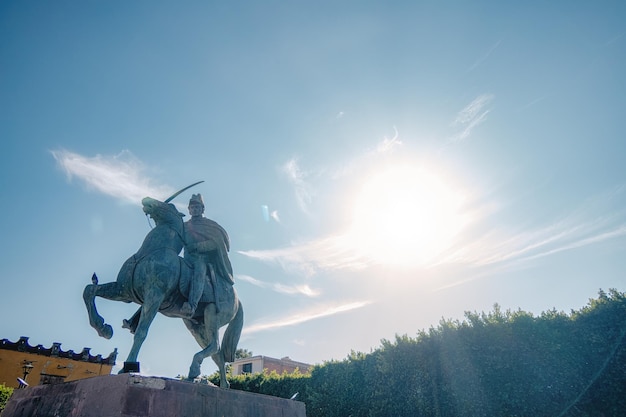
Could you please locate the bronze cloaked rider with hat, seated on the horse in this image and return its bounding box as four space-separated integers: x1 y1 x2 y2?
181 194 234 318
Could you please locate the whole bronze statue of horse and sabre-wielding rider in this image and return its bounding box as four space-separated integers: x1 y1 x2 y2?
83 181 243 388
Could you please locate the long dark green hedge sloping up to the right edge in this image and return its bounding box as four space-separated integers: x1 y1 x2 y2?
223 290 626 417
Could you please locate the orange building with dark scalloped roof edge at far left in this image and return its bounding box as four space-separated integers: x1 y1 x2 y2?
0 336 117 388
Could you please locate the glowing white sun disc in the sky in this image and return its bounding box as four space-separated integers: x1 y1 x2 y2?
349 166 465 266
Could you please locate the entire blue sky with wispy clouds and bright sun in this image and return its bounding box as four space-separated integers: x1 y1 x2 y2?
0 1 626 377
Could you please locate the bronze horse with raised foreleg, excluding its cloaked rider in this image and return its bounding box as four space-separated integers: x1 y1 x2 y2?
83 188 243 388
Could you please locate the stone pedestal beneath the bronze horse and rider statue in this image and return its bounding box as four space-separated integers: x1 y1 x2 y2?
2 374 306 417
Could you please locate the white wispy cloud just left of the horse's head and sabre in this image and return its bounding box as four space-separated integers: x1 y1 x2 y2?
50 149 174 204
